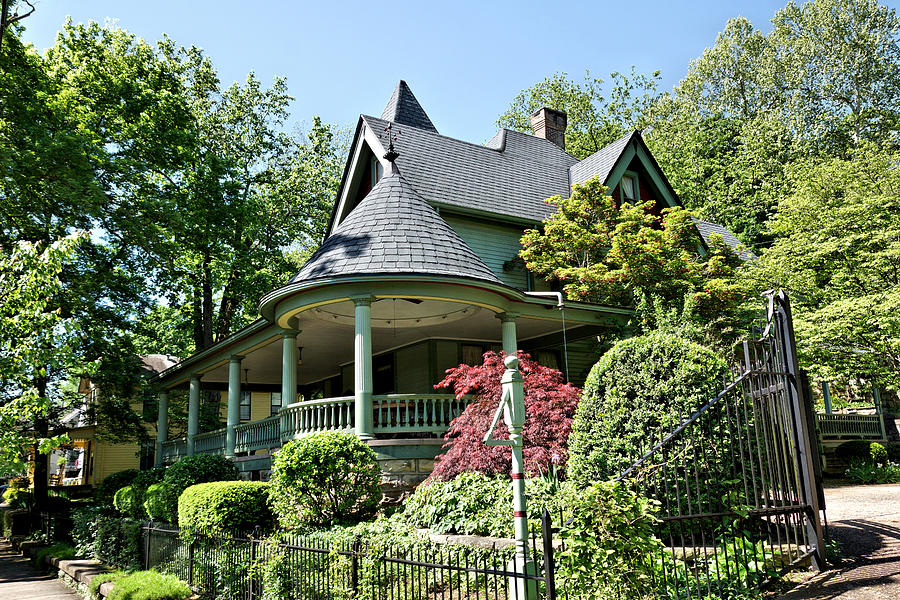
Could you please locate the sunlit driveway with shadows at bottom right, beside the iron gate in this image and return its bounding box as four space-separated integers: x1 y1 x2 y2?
781 485 900 600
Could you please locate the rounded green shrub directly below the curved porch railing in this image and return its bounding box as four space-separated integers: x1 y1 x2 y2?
270 431 381 530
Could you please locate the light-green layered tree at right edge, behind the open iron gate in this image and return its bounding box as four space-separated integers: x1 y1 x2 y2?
753 146 900 389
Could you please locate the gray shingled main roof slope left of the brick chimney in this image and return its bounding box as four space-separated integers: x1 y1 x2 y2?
362 115 578 221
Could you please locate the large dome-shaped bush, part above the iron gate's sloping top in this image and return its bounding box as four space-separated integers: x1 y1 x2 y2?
568 332 728 485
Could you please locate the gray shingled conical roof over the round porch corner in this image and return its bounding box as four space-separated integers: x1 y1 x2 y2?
290 167 501 283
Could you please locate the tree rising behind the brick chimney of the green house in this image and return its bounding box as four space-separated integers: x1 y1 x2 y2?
497 67 660 158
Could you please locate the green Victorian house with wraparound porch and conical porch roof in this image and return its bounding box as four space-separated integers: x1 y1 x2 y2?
149 81 737 485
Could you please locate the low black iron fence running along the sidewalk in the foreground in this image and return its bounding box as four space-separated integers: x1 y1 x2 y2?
143 513 557 600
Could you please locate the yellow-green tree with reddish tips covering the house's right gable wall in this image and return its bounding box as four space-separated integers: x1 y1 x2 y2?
520 177 747 340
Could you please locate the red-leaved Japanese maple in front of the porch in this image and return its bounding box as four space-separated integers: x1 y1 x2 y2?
430 352 581 481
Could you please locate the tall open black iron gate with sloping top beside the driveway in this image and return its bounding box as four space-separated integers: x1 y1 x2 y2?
619 294 824 599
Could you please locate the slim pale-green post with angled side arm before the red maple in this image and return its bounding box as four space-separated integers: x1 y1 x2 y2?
484 356 537 600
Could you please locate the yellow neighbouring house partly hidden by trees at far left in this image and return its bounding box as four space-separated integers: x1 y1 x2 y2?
43 354 178 486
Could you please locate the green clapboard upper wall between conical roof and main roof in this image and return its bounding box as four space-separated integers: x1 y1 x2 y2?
441 214 528 290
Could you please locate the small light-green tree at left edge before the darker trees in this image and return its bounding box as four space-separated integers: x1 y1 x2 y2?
0 234 85 478
